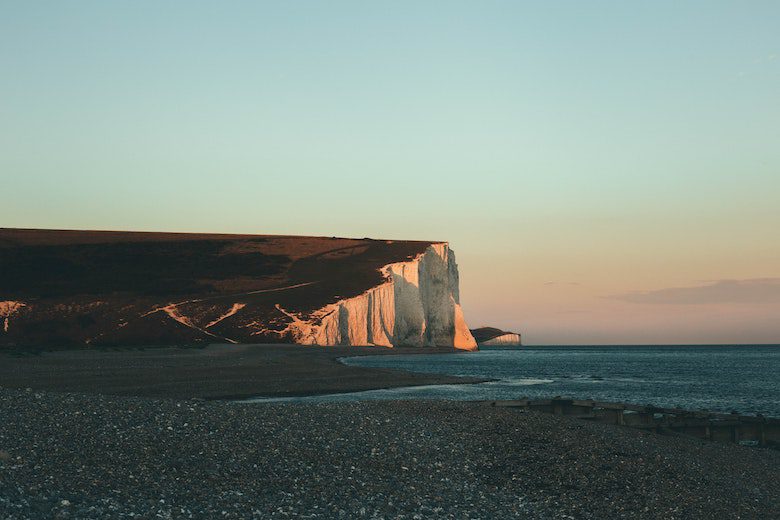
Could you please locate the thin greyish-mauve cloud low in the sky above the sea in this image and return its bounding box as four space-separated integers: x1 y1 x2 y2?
607 278 780 305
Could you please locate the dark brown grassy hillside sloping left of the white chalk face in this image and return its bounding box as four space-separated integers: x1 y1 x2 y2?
0 229 431 347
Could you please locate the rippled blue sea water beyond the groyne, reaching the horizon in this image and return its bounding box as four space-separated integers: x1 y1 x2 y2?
245 345 780 417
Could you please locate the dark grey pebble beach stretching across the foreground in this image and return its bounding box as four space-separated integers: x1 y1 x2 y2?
0 388 780 520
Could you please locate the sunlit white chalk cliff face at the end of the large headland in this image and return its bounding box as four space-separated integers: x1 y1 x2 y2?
278 243 477 350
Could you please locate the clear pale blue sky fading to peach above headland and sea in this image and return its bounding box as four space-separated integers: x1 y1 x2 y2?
0 0 780 345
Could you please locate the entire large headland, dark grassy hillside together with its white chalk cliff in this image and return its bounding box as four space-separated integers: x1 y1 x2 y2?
0 229 476 349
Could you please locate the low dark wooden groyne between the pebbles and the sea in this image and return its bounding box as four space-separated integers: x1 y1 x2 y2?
488 397 780 449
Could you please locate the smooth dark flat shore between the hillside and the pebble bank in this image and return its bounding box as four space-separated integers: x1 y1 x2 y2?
0 345 479 399
